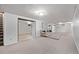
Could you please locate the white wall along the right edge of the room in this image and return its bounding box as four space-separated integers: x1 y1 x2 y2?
73 5 79 51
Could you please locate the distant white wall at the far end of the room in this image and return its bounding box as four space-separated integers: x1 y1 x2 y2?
55 22 72 32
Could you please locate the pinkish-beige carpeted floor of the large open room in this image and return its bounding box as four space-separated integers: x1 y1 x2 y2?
0 33 78 54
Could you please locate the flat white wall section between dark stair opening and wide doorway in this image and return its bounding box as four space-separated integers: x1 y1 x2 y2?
3 13 17 45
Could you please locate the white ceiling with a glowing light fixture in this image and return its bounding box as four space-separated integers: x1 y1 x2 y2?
0 4 75 23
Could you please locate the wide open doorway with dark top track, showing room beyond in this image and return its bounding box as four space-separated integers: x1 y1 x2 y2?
18 18 36 42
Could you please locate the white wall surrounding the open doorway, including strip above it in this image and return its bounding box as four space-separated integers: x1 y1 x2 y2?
3 12 41 45
